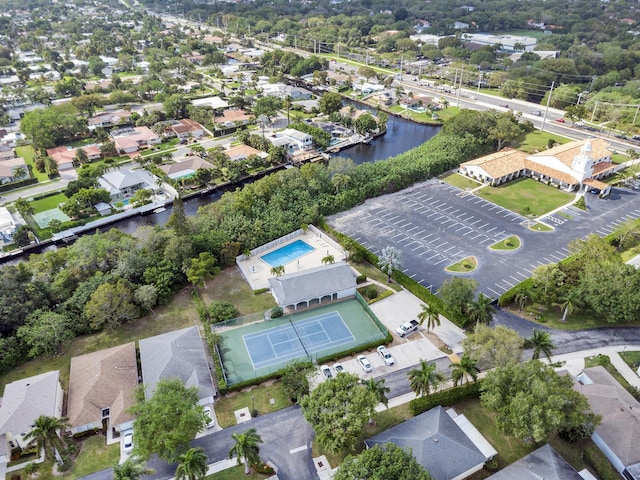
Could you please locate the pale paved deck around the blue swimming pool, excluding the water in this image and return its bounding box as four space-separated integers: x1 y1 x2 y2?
238 230 346 290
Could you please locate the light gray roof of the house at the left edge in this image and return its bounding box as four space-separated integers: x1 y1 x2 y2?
0 370 60 435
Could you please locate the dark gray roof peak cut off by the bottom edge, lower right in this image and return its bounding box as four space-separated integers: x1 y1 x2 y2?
487 444 582 480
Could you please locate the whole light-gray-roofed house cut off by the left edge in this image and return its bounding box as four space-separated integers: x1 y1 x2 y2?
0 370 64 463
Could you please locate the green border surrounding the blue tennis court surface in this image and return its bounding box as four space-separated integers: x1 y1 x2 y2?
218 298 387 386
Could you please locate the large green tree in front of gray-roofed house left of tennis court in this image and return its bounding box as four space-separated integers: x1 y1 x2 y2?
130 378 206 462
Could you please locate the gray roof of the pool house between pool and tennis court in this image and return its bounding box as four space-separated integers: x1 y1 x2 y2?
269 262 356 306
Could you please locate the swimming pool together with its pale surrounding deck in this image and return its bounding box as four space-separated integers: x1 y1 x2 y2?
236 227 345 290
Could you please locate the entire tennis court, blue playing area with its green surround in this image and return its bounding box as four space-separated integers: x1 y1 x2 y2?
214 299 387 385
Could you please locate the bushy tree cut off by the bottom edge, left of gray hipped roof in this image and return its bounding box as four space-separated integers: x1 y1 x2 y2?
333 442 431 480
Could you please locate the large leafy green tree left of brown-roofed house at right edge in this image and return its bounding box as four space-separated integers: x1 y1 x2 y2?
480 360 600 442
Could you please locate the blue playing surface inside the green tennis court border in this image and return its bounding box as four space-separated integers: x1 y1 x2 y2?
242 312 354 370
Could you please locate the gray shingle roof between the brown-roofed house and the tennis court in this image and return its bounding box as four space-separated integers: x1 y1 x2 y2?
139 327 215 399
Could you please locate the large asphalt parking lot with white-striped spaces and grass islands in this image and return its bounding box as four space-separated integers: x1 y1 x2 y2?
328 179 640 298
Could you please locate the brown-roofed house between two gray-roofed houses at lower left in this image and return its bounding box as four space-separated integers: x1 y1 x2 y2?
67 342 138 434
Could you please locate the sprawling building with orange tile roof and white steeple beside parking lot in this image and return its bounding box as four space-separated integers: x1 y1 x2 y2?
460 138 622 196
